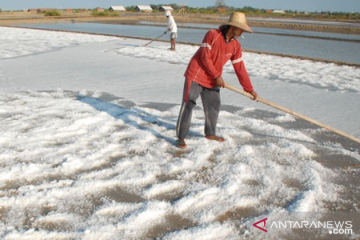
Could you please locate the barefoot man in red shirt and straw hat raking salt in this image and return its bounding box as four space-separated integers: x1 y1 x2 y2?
176 12 258 148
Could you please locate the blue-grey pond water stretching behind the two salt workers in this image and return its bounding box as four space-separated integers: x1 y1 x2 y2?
18 23 360 64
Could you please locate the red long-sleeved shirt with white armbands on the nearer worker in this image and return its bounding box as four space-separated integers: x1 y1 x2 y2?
185 29 254 92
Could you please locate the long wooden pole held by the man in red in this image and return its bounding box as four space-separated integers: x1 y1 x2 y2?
225 83 360 143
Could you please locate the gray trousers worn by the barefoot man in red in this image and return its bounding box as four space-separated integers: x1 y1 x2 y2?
176 80 221 138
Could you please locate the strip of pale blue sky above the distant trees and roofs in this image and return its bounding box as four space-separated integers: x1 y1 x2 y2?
0 0 360 12
